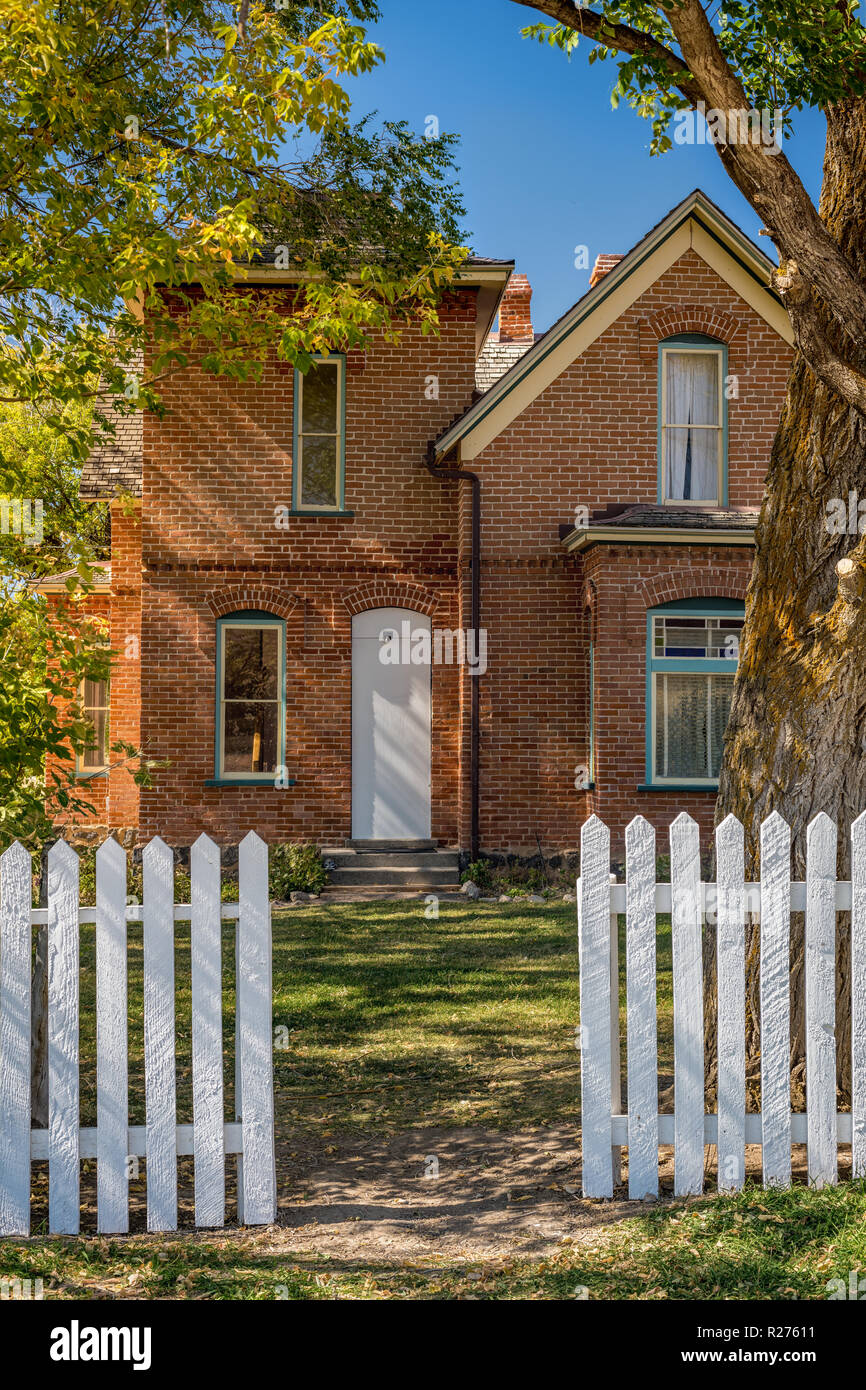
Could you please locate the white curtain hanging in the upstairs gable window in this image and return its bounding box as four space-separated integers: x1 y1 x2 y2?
664 352 720 502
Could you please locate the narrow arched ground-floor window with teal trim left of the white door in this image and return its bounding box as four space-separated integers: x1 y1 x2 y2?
215 613 285 781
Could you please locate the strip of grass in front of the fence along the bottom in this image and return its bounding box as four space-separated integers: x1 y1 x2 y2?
0 1182 866 1301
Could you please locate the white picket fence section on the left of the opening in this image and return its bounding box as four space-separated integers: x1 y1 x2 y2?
0 833 277 1236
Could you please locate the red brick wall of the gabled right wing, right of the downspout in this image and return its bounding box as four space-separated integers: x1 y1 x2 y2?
473 250 791 852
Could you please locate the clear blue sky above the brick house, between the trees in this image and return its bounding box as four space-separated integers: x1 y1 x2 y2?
352 0 824 331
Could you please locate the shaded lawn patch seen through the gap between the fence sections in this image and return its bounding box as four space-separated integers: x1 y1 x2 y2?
274 902 580 1130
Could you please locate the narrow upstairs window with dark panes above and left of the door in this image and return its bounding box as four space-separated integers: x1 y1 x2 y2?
292 353 346 513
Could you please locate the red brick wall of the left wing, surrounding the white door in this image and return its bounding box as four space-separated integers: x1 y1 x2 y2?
132 291 475 845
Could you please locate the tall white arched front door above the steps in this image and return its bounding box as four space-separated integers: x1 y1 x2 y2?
352 609 431 840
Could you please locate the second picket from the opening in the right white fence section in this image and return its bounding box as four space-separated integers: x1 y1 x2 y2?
626 816 659 1201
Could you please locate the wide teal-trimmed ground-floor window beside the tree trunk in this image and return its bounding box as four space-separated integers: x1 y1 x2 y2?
646 599 744 787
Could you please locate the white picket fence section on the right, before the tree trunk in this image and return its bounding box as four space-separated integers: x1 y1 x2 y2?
577 813 866 1200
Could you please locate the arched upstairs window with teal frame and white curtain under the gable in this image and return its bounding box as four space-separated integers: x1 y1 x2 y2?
659 334 727 506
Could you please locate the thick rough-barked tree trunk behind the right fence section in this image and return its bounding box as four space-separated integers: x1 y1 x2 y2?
705 101 866 1104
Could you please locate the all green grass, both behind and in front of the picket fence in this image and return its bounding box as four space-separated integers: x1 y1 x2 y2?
0 901 866 1300
